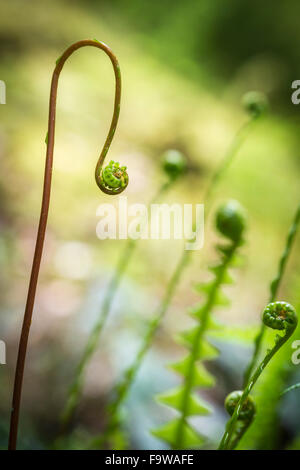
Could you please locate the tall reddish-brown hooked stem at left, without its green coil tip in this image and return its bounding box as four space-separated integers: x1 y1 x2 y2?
8 39 121 450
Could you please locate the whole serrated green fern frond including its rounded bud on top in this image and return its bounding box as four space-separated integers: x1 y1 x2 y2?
153 201 246 449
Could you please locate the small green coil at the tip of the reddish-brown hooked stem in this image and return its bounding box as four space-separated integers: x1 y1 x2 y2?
100 160 128 194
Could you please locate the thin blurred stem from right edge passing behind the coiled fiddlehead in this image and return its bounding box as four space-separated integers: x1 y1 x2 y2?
244 204 300 384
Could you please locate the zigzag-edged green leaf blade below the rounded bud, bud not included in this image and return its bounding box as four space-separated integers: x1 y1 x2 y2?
153 242 244 449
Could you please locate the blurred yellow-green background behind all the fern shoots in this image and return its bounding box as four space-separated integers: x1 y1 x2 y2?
0 0 300 449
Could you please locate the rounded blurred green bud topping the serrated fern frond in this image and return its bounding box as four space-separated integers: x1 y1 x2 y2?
216 200 246 243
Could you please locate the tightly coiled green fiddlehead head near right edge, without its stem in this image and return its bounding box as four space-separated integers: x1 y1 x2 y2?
263 302 298 330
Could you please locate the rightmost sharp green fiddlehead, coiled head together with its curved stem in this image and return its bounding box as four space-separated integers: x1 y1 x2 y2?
219 302 298 450
